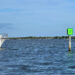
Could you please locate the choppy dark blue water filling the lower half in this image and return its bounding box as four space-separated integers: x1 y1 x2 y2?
0 39 75 75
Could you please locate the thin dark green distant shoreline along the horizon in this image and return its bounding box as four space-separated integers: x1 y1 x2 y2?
7 36 75 39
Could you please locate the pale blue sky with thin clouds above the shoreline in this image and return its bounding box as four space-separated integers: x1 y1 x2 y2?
0 0 75 37
